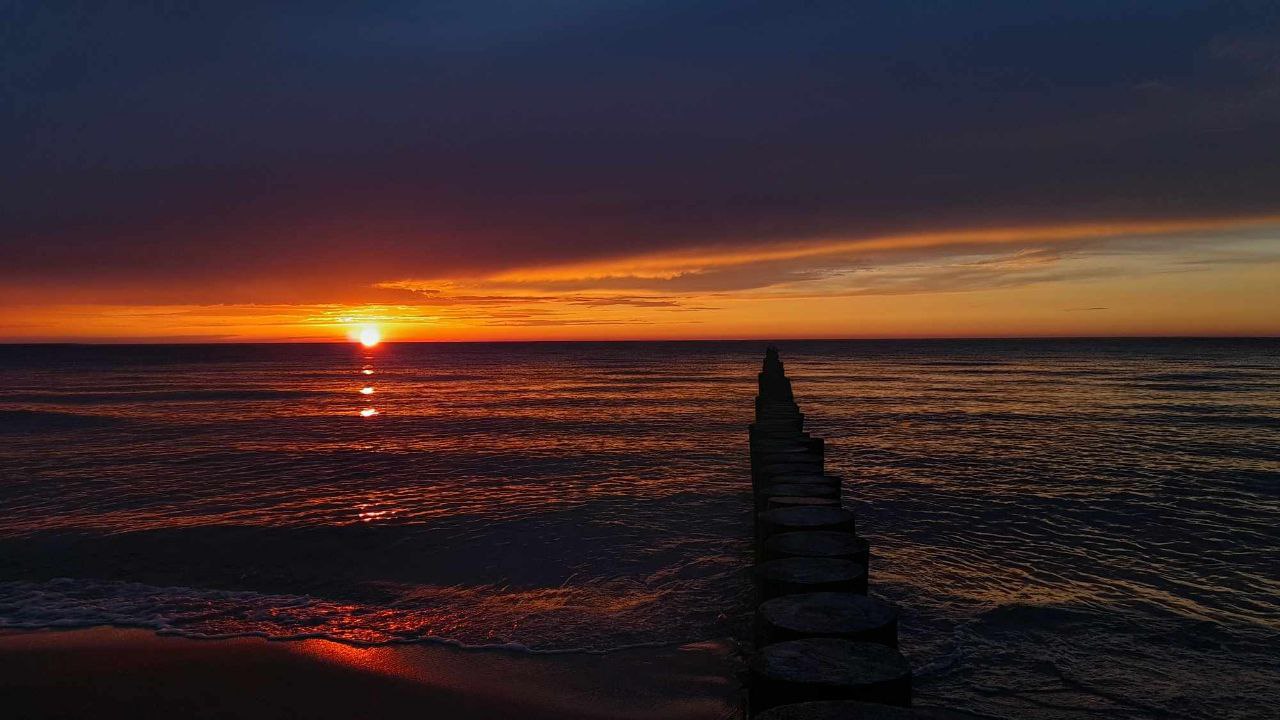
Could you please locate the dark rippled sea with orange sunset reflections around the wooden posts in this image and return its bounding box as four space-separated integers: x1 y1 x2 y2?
0 340 1280 719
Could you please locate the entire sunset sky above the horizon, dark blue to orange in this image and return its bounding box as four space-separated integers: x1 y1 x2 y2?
0 0 1280 342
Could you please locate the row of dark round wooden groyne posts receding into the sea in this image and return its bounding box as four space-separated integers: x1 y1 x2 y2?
748 347 911 720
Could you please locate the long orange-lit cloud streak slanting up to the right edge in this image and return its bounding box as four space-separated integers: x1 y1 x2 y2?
363 217 1280 299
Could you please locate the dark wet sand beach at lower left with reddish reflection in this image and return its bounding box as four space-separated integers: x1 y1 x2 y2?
0 628 737 720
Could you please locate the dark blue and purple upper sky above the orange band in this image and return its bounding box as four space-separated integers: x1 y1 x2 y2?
0 0 1280 301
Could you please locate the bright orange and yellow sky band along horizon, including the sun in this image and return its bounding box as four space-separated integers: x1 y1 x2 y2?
0 215 1280 340
